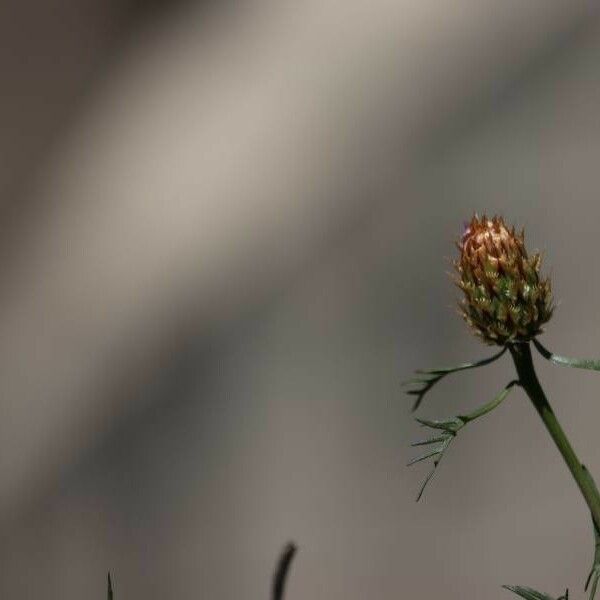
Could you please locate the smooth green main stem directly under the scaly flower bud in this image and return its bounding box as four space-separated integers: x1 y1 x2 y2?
510 343 600 526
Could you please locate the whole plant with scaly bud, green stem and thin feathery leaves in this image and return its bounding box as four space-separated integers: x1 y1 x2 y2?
405 216 600 600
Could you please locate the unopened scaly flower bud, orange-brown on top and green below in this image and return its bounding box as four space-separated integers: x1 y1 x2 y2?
454 215 553 345
